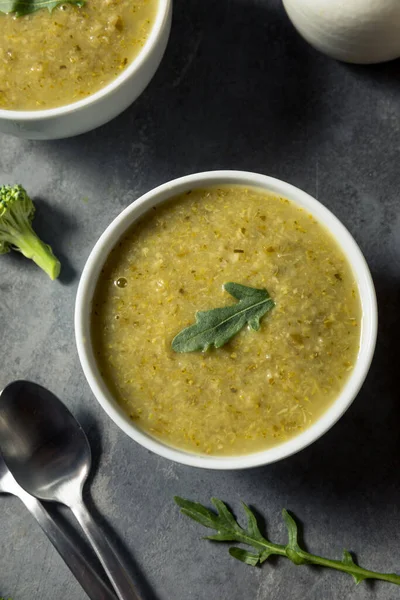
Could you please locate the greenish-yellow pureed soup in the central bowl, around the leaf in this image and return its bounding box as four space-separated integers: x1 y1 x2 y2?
91 186 361 455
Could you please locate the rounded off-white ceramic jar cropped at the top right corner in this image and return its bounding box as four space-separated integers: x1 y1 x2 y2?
283 0 400 64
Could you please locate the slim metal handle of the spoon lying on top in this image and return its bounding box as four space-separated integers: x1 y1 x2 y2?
70 501 140 600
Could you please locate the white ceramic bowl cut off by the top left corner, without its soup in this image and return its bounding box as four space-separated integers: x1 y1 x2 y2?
0 0 172 140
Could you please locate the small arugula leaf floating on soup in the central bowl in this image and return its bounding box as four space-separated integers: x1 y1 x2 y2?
172 282 275 352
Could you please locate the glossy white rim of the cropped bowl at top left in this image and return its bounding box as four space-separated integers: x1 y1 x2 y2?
0 0 172 122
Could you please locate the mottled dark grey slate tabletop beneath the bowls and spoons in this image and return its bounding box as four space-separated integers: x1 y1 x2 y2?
0 0 400 600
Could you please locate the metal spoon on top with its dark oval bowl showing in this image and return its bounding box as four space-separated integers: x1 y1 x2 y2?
0 381 139 600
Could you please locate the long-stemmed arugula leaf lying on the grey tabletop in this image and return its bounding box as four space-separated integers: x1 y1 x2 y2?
174 496 400 585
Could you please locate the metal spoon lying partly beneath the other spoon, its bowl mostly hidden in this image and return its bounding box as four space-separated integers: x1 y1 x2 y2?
0 455 115 600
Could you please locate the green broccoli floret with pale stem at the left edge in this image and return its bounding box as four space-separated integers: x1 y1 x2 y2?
0 185 61 279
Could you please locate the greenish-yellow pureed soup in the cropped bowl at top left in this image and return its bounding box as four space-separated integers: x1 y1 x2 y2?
0 0 158 110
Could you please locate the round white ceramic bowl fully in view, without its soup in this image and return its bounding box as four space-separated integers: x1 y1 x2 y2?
75 171 377 470
